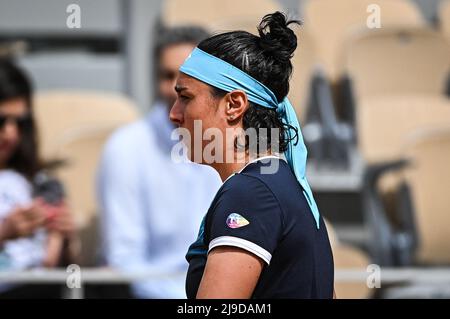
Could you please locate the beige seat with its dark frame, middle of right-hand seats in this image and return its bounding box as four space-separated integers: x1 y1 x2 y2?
356 94 450 265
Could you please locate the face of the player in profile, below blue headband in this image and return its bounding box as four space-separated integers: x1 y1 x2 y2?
170 73 230 163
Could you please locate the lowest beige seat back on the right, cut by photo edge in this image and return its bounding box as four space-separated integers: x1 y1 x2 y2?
405 124 450 265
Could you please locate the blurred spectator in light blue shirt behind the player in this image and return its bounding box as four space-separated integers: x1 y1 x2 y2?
98 27 221 298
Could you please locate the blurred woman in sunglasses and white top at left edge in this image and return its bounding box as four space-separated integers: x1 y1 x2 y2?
0 60 75 298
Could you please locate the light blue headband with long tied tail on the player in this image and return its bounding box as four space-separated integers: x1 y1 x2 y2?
180 48 320 228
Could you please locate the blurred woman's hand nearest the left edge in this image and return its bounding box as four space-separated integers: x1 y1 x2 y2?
0 202 45 241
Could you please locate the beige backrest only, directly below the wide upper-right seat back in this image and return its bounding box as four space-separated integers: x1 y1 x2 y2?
357 94 450 164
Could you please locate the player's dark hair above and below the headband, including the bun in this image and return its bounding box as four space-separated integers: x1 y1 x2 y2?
198 11 300 152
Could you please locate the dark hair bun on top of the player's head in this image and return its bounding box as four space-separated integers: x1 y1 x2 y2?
258 11 300 63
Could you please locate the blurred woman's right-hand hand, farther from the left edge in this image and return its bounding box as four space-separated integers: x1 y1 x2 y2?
44 202 76 238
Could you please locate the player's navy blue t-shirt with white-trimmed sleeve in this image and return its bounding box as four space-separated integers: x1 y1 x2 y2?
186 157 334 299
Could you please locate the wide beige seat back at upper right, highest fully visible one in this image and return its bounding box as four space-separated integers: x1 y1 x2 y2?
345 27 450 107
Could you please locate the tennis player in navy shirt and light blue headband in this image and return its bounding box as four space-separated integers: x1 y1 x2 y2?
170 12 334 298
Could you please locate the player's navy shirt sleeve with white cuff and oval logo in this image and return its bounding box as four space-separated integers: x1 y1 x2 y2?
208 175 283 264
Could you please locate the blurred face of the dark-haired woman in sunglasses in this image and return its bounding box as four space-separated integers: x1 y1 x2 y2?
0 98 28 167
